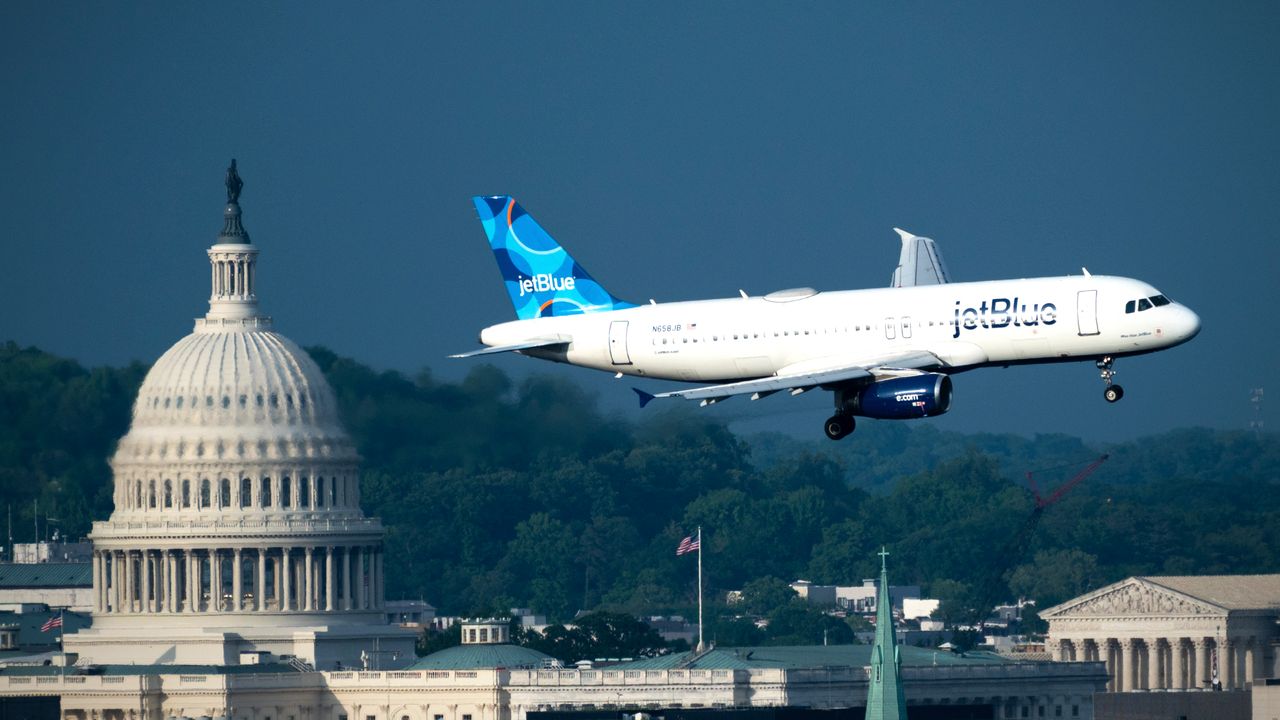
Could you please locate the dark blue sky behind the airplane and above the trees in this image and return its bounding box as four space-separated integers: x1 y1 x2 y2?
0 1 1280 442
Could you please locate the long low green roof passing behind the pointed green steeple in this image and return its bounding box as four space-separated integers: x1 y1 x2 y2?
613 644 1011 670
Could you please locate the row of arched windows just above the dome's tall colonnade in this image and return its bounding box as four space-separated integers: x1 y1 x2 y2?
132 475 353 510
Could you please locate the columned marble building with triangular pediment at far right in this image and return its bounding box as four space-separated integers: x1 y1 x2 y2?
1041 575 1280 692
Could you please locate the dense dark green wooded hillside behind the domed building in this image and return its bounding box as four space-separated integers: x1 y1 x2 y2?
0 343 1280 625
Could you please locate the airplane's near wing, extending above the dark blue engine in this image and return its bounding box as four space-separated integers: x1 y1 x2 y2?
632 350 946 407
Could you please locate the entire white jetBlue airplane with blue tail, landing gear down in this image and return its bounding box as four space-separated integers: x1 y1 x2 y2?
452 196 1201 439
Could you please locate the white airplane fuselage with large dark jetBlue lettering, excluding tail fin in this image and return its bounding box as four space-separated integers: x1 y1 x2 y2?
480 275 1199 383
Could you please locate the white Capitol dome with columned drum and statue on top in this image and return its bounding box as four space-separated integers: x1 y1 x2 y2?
67 160 413 666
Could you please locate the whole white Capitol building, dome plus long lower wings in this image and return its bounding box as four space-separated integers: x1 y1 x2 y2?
0 161 1108 720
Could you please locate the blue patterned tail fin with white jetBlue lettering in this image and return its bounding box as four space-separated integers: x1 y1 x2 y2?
471 195 635 320
